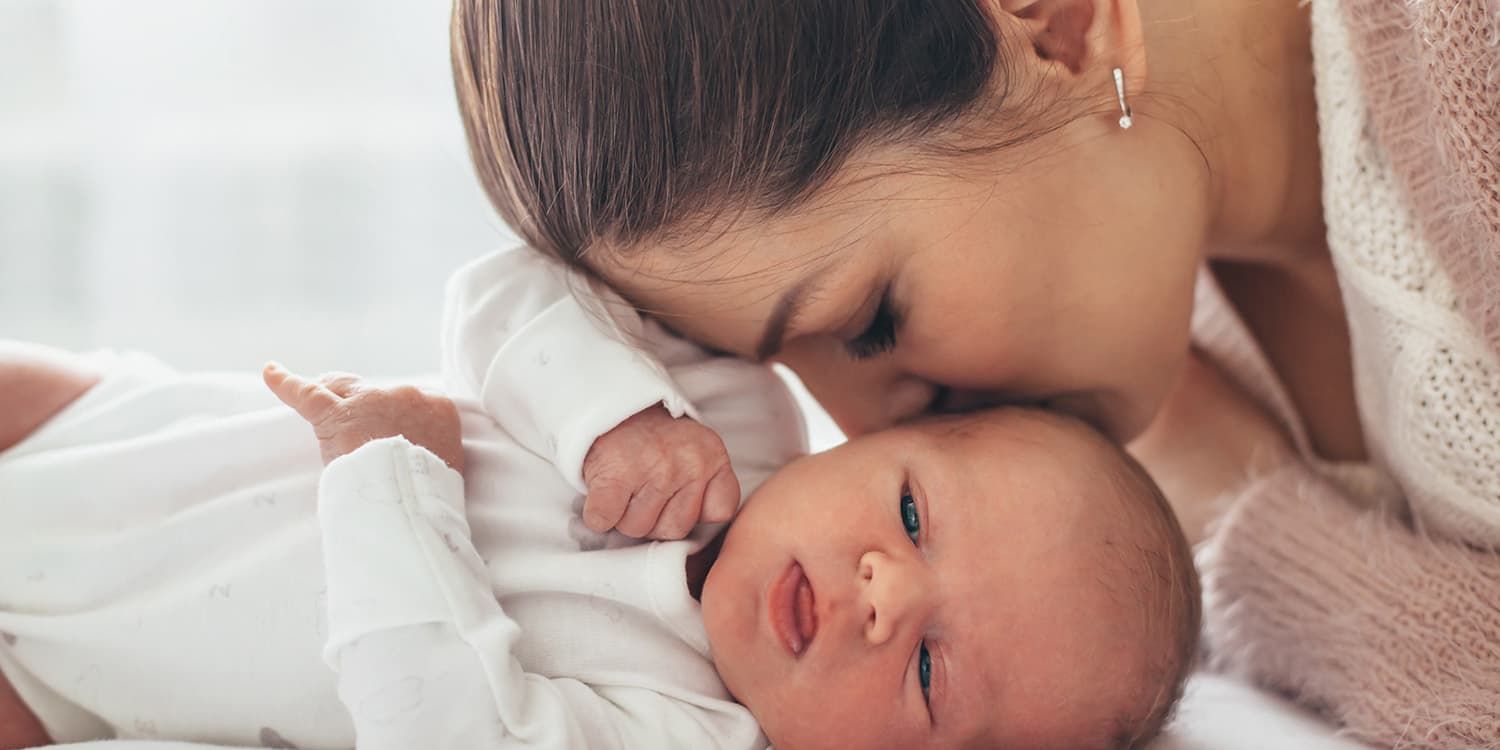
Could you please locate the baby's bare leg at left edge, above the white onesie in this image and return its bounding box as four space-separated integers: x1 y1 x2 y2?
0 341 99 452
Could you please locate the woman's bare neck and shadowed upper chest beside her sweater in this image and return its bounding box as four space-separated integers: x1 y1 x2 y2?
1142 0 1365 461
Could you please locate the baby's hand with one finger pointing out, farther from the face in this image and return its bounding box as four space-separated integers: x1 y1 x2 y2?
261 362 464 473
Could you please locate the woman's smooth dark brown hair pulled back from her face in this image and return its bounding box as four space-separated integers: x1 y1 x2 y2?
452 0 1020 266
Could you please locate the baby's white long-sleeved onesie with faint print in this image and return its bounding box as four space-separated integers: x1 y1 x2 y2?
0 249 806 750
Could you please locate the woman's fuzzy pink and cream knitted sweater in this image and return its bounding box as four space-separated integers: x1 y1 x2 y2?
1194 0 1500 749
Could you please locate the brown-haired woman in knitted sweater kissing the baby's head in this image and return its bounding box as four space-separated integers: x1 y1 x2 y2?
455 0 1500 747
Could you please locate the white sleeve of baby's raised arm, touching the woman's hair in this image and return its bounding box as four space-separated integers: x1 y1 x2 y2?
443 248 696 492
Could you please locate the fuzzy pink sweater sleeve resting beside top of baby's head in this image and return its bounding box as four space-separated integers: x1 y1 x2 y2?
1199 465 1500 750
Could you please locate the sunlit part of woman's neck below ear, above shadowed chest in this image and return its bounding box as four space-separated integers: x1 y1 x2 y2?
1142 0 1326 267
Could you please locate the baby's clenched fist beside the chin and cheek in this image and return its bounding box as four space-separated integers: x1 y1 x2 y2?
584 405 740 539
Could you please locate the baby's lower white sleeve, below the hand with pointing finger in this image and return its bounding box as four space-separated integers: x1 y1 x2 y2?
318 437 744 750
